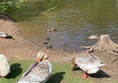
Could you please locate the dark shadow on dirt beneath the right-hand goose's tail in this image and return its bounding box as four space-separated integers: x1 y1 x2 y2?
89 70 111 78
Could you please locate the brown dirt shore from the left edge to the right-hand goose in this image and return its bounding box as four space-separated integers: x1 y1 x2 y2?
0 20 73 62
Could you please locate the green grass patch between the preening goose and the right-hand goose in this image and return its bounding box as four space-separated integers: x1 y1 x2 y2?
47 62 95 83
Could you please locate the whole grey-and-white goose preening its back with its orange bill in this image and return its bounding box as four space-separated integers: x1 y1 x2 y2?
18 51 52 83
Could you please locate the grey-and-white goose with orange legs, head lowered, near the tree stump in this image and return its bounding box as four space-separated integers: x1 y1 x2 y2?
72 53 105 79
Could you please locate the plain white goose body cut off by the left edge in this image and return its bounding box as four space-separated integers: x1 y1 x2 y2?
0 54 10 77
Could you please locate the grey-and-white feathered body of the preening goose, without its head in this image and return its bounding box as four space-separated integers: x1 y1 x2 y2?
18 60 52 83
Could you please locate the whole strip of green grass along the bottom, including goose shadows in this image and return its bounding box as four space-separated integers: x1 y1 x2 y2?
0 60 118 83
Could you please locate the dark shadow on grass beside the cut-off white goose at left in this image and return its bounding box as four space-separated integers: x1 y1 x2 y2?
6 63 22 79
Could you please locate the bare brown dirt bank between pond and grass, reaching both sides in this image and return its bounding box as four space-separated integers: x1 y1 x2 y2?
0 20 118 79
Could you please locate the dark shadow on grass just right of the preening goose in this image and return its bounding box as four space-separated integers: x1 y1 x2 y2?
46 72 65 83
